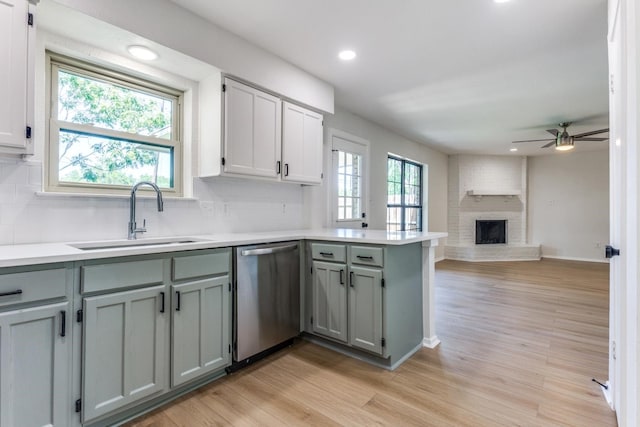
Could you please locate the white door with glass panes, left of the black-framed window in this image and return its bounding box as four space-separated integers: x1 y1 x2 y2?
329 129 369 228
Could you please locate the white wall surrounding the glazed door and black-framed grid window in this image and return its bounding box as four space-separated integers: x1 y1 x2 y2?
305 106 447 257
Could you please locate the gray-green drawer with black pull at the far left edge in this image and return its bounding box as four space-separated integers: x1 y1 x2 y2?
0 268 67 307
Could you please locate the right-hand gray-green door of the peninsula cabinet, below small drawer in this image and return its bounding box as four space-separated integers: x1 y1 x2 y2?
349 266 383 354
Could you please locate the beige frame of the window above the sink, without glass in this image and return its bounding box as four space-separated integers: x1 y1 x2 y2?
44 51 184 197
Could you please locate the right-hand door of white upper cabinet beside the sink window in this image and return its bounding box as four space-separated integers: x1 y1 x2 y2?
282 102 322 184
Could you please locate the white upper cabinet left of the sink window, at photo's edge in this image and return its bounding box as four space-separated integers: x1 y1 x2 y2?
0 0 35 154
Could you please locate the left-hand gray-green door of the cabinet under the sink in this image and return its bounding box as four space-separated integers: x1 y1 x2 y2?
82 286 169 422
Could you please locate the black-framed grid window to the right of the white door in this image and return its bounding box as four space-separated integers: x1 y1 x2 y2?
387 156 423 231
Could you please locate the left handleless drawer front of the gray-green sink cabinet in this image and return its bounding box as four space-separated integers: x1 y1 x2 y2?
80 259 163 293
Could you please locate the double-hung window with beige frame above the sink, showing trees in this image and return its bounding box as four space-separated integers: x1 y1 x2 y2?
46 54 183 196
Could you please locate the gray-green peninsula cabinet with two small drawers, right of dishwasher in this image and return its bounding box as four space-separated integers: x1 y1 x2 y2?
305 242 422 369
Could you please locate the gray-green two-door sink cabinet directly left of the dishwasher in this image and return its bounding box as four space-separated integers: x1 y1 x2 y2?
78 248 232 426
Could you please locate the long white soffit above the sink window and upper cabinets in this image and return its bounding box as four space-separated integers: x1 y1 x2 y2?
51 0 334 113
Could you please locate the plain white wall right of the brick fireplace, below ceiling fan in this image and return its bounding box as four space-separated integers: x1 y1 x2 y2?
528 151 609 261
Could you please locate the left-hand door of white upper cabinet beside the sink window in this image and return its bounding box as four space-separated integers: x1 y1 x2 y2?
223 79 282 179
